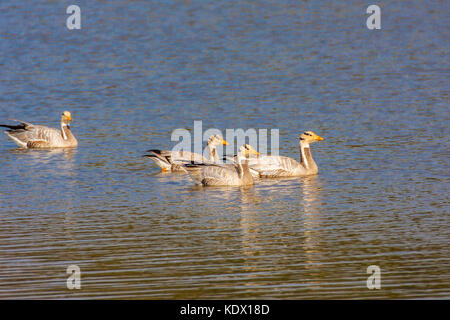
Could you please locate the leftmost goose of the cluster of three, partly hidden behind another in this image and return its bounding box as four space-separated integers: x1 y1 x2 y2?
144 134 228 172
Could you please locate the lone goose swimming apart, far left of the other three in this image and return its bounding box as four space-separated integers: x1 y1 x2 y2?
0 111 78 149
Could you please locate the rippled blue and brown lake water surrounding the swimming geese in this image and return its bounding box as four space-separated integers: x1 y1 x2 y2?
0 0 450 299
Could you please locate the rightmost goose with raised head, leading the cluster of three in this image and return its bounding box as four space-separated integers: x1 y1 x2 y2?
249 131 324 178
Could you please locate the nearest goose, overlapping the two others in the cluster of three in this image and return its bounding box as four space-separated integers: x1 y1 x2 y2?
184 144 259 186
